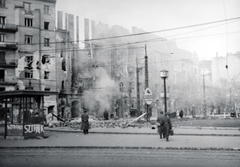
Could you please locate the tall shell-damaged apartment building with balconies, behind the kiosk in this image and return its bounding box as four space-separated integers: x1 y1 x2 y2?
0 0 57 120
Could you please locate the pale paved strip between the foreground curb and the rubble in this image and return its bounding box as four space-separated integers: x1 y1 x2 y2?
0 127 240 151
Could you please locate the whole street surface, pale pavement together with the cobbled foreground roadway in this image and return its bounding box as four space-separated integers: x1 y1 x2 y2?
0 128 240 167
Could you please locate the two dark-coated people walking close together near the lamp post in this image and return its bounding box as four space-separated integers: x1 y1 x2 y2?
157 111 172 141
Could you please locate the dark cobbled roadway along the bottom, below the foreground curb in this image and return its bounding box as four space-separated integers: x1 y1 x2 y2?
0 148 240 167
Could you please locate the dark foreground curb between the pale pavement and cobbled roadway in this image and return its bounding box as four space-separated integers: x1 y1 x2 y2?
0 146 240 151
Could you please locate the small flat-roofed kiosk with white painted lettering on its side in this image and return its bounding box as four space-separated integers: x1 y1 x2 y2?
0 90 57 139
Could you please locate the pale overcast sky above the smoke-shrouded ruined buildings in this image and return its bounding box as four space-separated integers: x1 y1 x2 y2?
56 0 240 59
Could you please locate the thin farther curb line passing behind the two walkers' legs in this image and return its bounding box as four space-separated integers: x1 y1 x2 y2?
45 130 240 137
